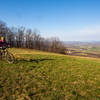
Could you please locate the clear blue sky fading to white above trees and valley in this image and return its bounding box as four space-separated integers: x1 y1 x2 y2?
0 0 100 41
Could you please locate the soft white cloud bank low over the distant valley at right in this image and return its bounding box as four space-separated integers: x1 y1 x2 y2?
61 25 100 41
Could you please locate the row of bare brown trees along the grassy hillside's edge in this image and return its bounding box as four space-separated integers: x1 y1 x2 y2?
0 21 66 54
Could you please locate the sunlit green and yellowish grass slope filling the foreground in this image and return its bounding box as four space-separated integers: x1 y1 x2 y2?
0 48 100 100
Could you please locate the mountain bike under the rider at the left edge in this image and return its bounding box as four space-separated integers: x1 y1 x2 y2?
0 47 15 63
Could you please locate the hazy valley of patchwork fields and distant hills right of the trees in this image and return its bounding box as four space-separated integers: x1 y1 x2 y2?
66 42 100 58
